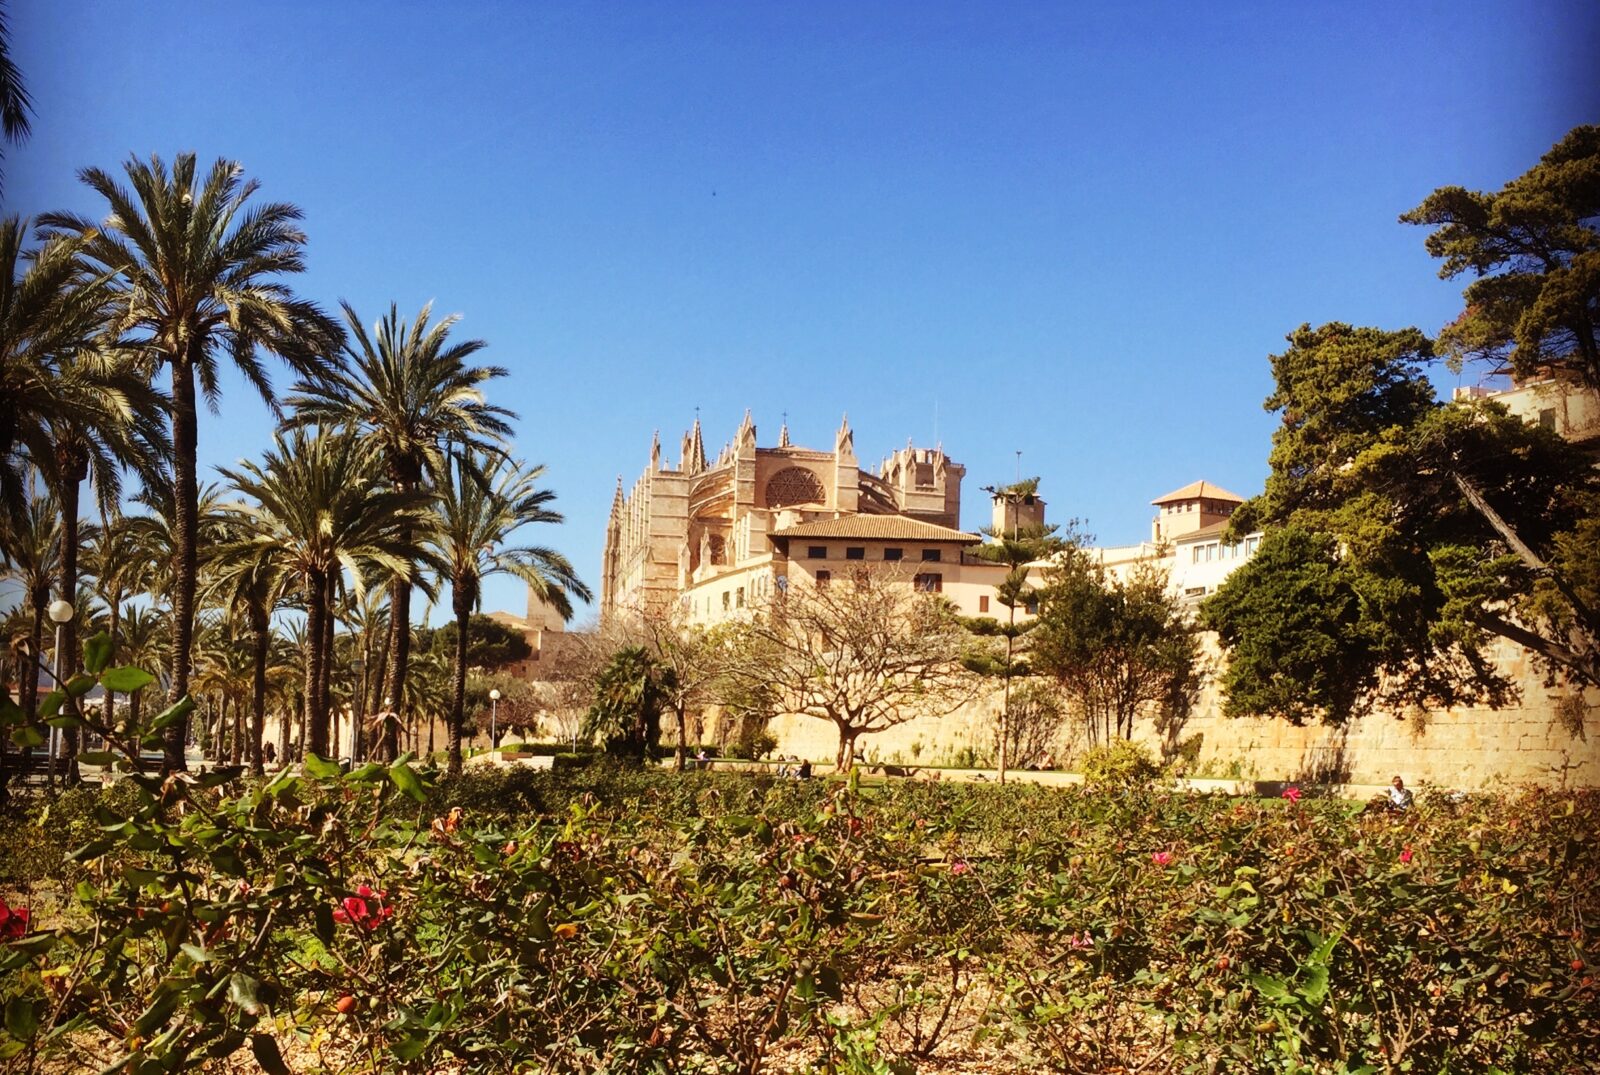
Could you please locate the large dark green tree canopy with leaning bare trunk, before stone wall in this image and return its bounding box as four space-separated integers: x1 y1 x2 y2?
1203 323 1600 720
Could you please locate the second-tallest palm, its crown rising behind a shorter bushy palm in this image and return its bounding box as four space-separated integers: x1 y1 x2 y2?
288 302 515 760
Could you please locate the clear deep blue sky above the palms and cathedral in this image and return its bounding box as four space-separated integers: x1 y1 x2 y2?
5 0 1600 617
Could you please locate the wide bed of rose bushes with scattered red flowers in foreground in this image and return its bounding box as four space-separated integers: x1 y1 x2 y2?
0 659 1600 1075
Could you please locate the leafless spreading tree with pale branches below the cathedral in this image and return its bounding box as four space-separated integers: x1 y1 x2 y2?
725 571 976 773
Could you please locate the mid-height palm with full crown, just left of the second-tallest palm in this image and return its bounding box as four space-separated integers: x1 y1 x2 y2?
222 430 432 755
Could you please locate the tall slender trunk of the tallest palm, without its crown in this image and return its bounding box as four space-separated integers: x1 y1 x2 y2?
162 361 200 773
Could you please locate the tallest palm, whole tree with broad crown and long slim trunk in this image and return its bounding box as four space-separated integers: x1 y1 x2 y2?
42 154 342 769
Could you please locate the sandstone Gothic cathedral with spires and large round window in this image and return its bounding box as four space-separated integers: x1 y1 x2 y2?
600 411 997 622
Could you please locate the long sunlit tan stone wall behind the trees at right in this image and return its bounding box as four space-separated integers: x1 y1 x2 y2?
771 638 1600 789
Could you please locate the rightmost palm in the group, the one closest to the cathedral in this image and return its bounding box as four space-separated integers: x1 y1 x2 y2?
432 453 592 773
